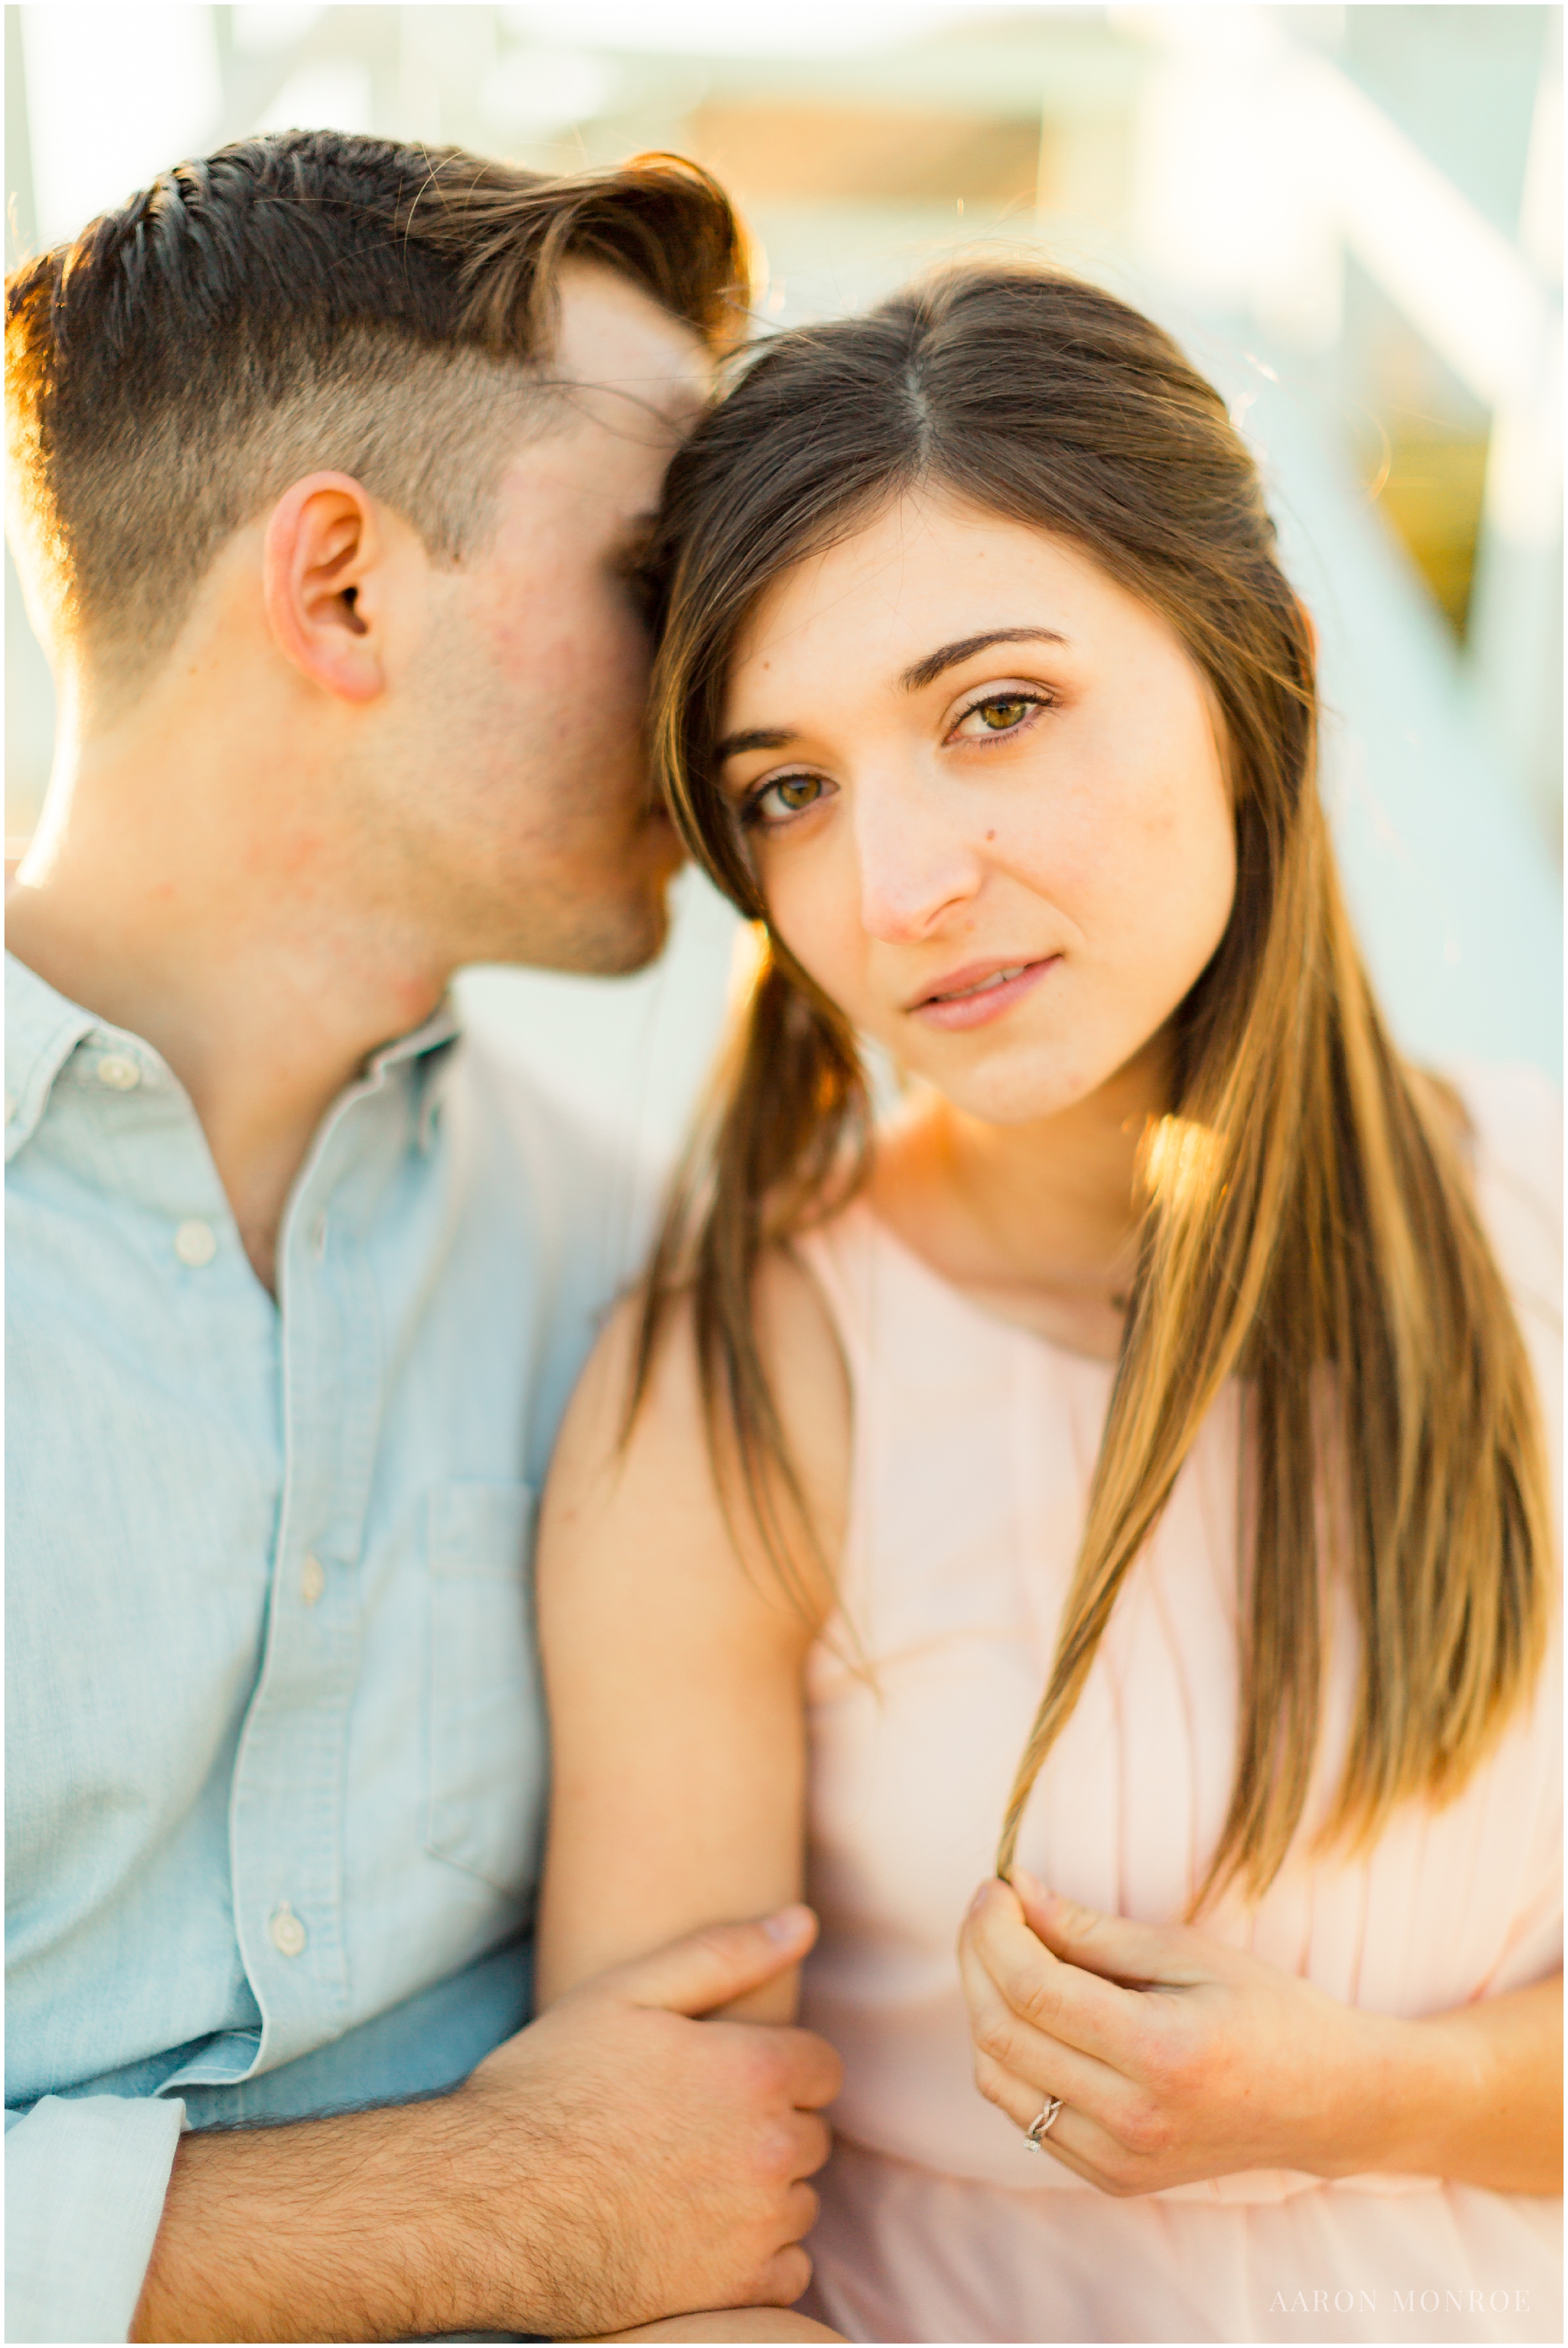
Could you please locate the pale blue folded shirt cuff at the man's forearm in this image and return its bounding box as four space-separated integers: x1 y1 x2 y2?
4 2094 185 2341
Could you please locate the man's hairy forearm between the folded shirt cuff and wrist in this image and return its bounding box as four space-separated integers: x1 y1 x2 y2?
131 2097 502 2341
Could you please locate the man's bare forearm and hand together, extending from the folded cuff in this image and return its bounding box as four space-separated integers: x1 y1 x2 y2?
134 1909 840 2341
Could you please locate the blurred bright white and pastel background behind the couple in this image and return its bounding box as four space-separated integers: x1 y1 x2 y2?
4 0 1564 1158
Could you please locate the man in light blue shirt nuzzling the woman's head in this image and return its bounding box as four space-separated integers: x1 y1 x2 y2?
7 134 838 2341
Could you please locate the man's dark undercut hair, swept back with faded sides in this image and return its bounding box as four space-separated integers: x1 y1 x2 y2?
4 131 749 695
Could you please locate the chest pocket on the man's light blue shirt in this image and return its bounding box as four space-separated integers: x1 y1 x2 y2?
425 1482 547 1897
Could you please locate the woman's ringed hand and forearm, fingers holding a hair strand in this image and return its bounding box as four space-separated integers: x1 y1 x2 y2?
960 1871 1561 2196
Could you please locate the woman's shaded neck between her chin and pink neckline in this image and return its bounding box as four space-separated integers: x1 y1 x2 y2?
871 1035 1172 1359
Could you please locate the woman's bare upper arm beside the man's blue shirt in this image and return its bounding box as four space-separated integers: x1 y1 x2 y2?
537 1258 850 2022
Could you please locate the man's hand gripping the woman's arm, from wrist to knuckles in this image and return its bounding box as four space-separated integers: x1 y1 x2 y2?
453 1907 843 2337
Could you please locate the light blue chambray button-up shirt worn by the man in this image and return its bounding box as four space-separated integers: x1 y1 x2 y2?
4 960 636 2341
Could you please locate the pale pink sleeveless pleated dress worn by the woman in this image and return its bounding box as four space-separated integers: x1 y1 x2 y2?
805 1070 1564 2341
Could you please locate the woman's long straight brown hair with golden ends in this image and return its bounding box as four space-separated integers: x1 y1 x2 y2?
634 268 1551 1909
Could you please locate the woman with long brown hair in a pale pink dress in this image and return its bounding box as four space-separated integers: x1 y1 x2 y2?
540 270 1561 2338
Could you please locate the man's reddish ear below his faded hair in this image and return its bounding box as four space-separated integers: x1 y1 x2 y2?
261 472 388 702
